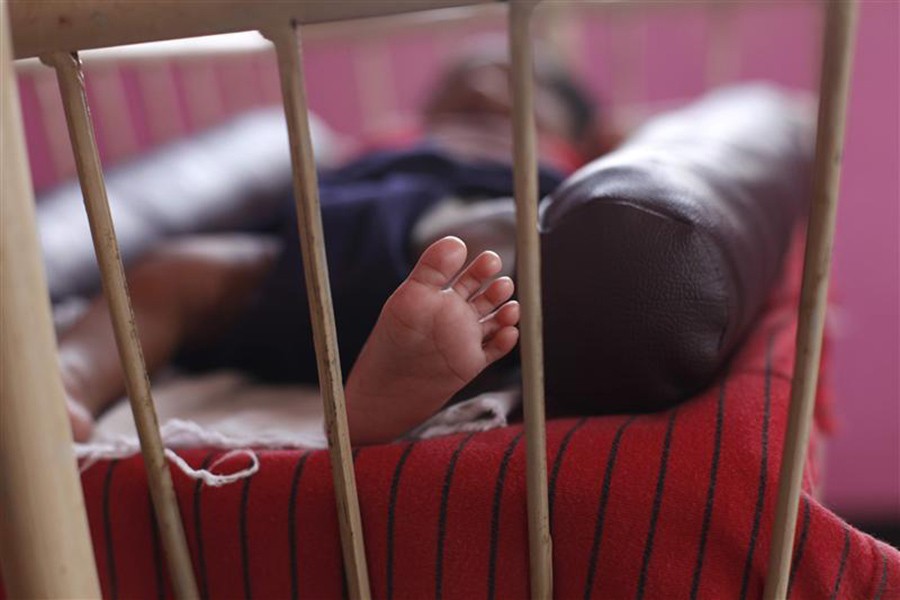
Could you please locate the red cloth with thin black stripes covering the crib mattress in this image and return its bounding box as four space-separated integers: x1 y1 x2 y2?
3 241 900 599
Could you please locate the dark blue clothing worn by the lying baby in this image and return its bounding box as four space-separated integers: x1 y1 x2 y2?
179 146 562 382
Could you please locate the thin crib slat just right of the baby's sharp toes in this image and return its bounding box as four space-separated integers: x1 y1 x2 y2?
509 0 553 598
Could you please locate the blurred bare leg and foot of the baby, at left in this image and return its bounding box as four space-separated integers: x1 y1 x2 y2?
59 235 277 440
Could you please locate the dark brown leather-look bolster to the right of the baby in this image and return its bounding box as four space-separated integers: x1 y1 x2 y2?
541 85 814 413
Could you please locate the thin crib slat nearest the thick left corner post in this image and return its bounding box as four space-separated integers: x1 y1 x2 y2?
42 52 199 598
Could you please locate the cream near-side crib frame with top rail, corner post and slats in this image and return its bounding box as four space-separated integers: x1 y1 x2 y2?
0 0 856 598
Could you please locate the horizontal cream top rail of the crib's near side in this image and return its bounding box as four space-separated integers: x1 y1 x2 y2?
9 0 488 58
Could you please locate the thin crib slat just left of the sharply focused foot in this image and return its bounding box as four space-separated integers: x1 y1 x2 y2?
265 25 371 598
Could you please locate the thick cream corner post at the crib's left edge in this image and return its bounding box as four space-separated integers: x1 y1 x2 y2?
0 4 100 598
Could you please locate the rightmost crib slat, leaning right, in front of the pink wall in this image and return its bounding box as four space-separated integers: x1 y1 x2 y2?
765 0 857 599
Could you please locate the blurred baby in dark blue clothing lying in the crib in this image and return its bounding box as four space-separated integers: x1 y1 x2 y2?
60 35 601 443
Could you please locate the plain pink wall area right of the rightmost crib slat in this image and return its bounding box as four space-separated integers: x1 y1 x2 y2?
825 2 900 518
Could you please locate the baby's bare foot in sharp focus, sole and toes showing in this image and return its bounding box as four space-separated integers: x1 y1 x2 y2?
346 237 519 444
